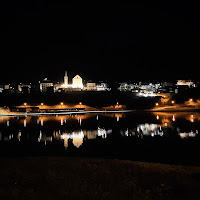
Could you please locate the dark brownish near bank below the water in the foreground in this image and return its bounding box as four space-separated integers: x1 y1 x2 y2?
0 157 200 200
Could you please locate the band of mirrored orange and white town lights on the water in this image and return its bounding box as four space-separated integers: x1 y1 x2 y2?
0 112 200 149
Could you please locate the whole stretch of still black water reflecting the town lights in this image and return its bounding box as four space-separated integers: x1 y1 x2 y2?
0 112 200 163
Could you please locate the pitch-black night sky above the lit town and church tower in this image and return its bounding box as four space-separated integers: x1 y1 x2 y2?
0 0 200 82
